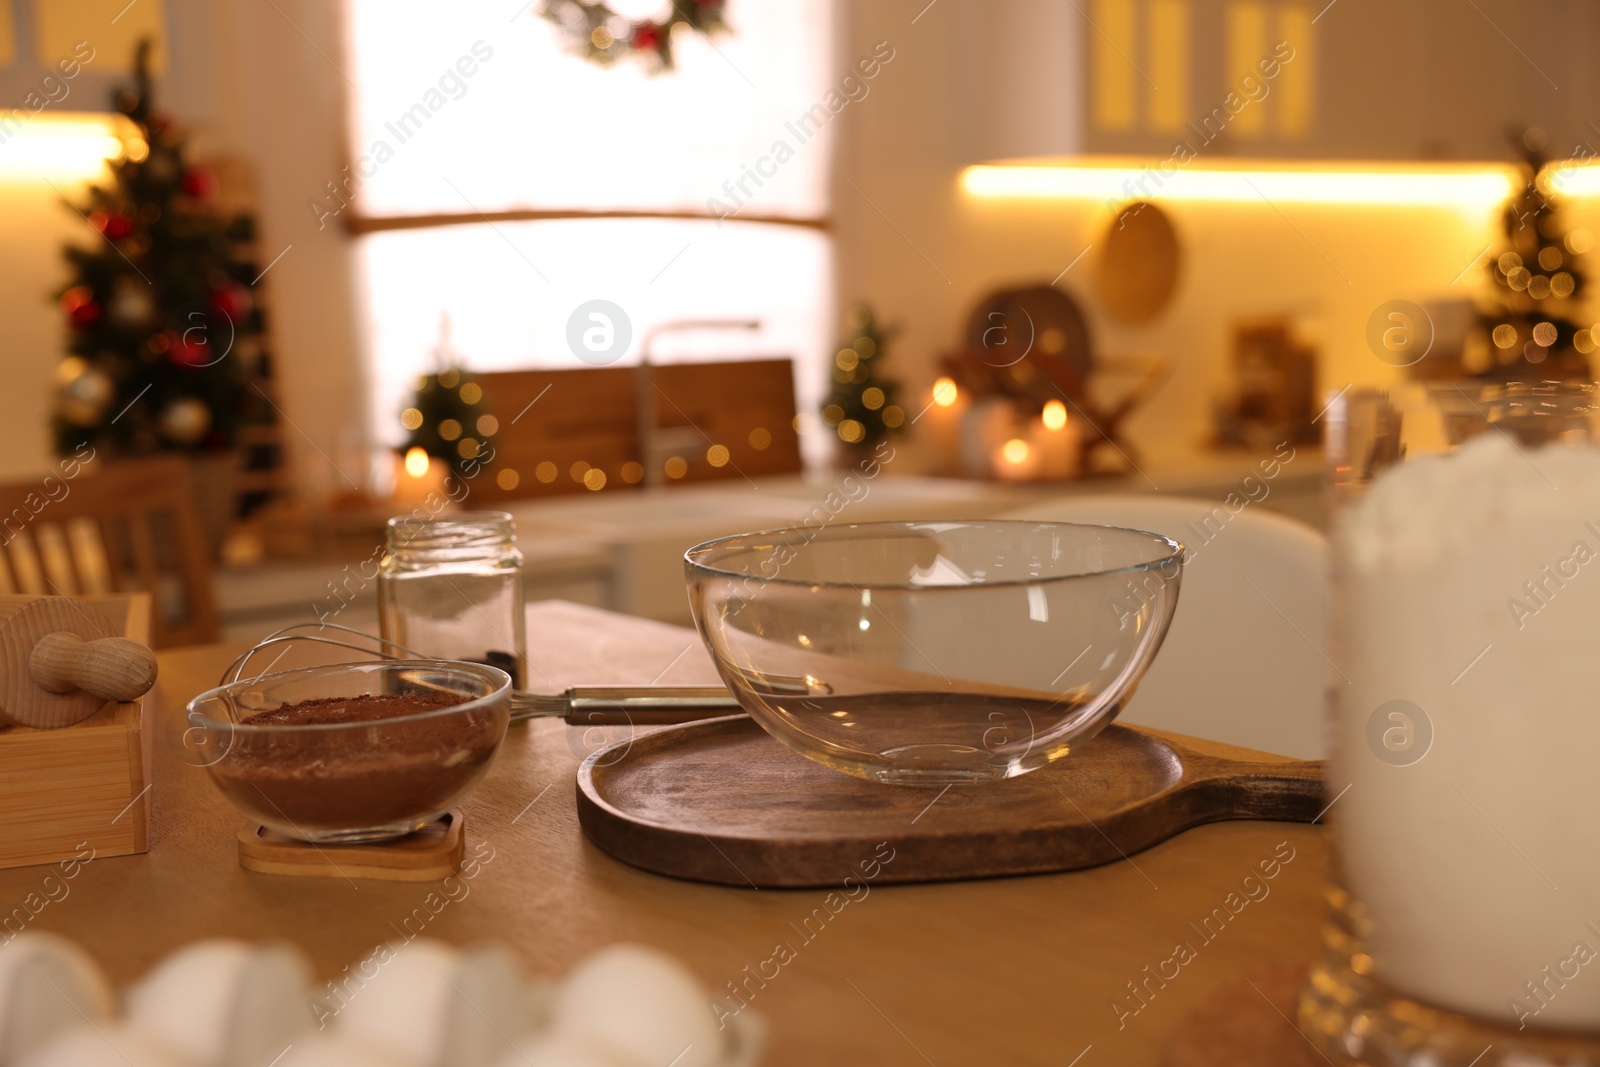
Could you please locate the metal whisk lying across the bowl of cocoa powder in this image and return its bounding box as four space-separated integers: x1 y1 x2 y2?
221 622 755 726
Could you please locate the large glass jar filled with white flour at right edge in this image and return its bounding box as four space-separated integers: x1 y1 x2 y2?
1299 382 1600 1067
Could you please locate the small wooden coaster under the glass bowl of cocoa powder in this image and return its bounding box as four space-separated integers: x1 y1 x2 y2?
238 809 467 881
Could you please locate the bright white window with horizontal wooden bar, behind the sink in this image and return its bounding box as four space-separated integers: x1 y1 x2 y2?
337 0 835 467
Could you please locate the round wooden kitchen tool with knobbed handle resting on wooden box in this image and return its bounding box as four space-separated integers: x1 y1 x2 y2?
0 597 155 729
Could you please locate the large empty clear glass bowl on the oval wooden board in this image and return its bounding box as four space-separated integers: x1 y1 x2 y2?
685 522 1184 784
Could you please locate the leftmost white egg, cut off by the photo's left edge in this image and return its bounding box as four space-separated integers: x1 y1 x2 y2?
0 933 115 1067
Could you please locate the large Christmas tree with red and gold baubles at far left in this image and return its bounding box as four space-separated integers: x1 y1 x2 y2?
54 42 270 456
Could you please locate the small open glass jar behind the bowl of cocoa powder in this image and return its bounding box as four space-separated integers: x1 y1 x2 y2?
378 512 528 689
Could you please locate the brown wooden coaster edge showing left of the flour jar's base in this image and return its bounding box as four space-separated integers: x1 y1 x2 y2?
1162 963 1326 1067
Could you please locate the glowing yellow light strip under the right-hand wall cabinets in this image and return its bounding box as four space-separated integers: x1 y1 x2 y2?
962 160 1516 210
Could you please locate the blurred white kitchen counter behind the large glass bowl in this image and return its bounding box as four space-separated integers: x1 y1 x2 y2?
216 448 1322 637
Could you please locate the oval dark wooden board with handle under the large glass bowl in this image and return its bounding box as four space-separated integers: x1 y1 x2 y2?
578 715 1323 888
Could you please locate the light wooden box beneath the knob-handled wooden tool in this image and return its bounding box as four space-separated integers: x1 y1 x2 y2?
0 593 154 867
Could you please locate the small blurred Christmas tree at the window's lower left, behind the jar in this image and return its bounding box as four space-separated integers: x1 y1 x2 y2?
400 315 499 477
